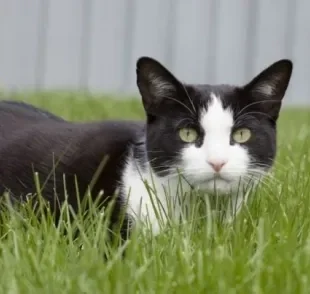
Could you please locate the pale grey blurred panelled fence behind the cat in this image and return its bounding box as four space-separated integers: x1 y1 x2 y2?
0 0 310 106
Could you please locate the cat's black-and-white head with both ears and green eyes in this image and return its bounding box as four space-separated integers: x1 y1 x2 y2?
137 57 293 192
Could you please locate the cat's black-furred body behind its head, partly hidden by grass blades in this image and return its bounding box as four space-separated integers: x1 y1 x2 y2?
0 101 144 239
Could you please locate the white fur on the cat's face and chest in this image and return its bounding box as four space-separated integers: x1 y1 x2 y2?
122 94 264 234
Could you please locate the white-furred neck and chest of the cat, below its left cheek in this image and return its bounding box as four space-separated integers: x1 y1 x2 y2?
121 140 190 234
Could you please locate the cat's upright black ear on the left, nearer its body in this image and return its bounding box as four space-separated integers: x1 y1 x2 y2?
136 57 181 113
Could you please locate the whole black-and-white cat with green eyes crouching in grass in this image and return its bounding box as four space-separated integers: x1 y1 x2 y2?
0 57 293 238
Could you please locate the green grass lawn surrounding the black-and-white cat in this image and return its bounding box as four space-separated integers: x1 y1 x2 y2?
0 93 310 294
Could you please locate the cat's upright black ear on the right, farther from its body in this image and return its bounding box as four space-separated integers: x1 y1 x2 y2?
244 59 293 120
